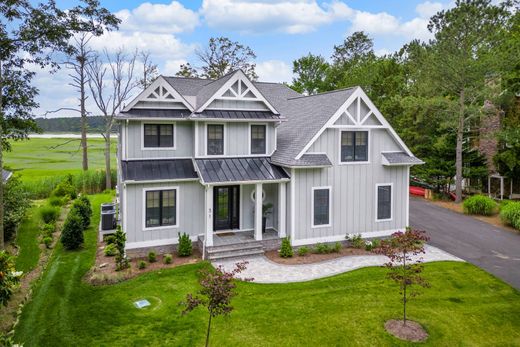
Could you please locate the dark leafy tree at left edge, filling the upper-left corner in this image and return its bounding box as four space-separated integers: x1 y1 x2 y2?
0 0 119 248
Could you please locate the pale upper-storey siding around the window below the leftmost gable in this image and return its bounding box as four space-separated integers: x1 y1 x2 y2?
126 121 194 159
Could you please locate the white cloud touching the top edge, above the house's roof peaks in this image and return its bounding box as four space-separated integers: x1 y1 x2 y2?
200 0 352 34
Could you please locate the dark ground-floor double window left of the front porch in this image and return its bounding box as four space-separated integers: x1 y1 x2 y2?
145 189 177 228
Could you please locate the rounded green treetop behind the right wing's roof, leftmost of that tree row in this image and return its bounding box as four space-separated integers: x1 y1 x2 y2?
291 53 330 95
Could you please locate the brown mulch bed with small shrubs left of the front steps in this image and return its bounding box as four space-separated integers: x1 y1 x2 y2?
86 242 202 285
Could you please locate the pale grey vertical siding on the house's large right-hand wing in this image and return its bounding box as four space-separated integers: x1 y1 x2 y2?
294 129 408 240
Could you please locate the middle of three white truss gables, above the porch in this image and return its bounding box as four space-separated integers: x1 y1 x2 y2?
197 70 278 114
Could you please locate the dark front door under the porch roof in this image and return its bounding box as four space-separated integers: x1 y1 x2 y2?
213 186 240 231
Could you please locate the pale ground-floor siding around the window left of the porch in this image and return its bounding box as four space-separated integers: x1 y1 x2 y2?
123 181 205 244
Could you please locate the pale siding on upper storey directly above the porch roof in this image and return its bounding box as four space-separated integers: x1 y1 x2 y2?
197 119 276 157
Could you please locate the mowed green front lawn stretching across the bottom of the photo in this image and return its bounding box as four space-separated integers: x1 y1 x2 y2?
15 195 520 346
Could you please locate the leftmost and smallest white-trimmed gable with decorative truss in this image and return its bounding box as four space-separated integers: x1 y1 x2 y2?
124 76 193 111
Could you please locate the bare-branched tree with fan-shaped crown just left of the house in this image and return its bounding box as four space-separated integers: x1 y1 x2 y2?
87 49 138 189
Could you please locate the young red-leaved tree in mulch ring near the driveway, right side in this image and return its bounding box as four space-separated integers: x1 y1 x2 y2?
376 228 430 325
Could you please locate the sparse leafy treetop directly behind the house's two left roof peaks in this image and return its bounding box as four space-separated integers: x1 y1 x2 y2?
195 37 258 80
